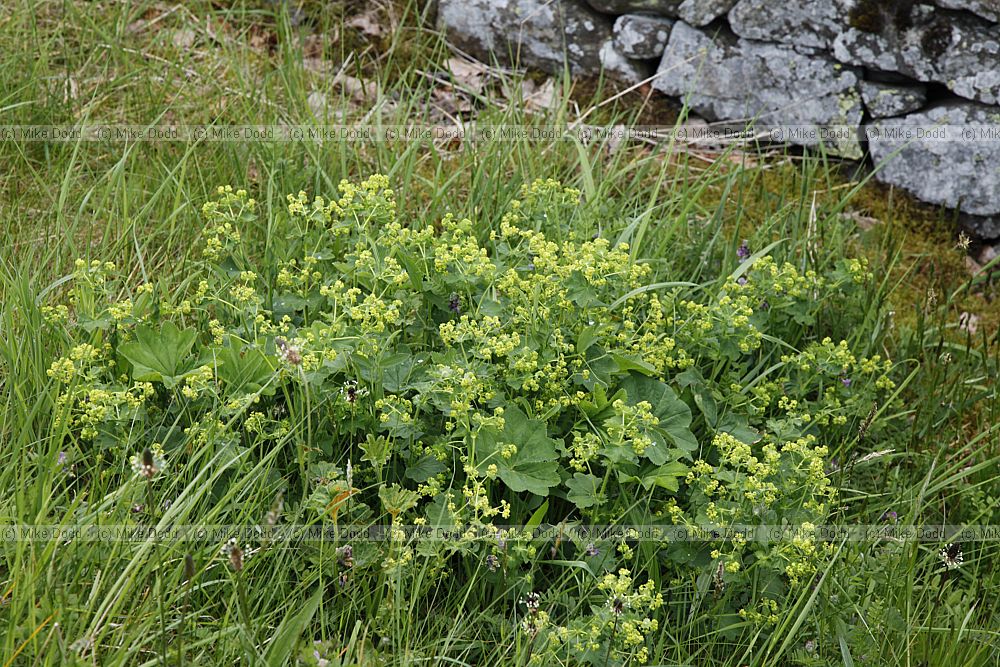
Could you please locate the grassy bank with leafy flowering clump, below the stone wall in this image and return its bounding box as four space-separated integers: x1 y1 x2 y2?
0 3 1000 665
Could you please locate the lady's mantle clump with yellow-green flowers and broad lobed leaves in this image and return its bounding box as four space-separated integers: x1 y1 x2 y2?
46 176 894 664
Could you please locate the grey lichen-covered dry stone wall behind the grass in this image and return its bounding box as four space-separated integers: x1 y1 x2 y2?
438 0 1000 238
